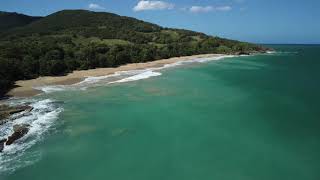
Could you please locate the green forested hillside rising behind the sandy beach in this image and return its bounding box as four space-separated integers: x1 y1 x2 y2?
0 10 265 96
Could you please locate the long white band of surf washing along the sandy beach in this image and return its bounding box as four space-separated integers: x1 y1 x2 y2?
35 55 235 93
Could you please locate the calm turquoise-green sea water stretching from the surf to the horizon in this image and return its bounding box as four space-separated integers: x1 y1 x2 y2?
0 46 320 180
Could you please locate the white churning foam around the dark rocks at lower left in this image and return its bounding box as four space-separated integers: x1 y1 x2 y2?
0 99 63 174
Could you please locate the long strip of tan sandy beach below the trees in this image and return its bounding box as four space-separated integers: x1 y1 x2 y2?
7 54 226 97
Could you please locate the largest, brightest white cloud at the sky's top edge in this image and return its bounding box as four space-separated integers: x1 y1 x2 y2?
133 0 174 11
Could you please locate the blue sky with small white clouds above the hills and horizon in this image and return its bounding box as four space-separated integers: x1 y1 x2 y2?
0 0 320 44
